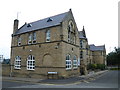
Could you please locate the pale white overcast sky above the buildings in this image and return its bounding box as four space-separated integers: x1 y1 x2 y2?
0 0 119 58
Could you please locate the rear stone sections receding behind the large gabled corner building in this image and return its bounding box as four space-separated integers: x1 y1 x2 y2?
79 26 106 74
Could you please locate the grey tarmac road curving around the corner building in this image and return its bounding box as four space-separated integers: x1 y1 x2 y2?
3 71 120 88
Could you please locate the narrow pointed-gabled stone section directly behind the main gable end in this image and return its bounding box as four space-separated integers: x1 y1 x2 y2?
79 26 90 74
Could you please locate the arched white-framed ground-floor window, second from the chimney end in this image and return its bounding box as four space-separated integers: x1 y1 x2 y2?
27 55 35 70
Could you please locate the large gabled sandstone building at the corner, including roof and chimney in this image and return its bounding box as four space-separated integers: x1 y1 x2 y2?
11 9 80 78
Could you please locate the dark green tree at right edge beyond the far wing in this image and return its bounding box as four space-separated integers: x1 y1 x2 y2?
107 48 120 65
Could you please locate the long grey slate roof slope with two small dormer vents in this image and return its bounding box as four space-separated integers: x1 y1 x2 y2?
15 12 68 35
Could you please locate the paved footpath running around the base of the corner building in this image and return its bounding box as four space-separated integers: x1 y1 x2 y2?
2 70 108 85
